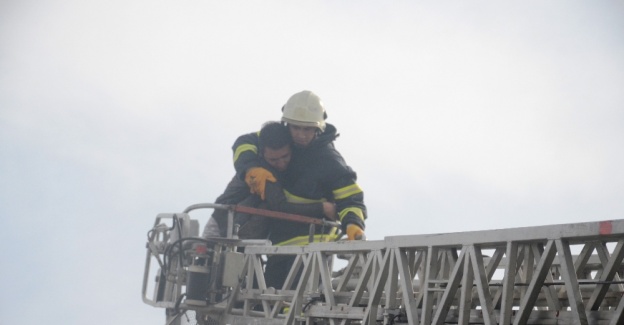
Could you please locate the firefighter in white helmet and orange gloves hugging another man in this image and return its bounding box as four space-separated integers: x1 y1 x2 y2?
232 90 366 288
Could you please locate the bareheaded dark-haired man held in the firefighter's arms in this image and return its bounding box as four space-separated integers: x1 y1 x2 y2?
203 122 336 239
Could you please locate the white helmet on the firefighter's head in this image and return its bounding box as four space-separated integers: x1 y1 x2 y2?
282 90 327 132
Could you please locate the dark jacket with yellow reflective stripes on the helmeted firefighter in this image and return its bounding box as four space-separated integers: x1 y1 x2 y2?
232 124 366 245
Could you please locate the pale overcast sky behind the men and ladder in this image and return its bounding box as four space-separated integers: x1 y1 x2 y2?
0 0 624 325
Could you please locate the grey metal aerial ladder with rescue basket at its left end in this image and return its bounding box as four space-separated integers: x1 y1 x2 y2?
142 203 624 325
